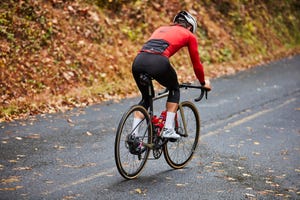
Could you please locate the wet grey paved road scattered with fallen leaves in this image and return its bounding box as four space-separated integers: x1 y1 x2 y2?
0 56 300 200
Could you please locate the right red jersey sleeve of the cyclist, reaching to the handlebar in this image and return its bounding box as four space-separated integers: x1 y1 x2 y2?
188 36 205 85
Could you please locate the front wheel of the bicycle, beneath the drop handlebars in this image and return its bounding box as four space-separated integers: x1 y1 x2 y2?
164 101 200 169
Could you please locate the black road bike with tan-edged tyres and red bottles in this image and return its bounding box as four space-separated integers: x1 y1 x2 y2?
115 74 207 179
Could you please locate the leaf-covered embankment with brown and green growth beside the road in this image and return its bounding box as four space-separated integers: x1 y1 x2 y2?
0 0 300 121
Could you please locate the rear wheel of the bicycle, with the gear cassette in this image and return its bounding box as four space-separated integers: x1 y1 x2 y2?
115 105 152 179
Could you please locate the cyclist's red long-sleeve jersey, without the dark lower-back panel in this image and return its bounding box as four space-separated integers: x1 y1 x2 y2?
144 25 205 84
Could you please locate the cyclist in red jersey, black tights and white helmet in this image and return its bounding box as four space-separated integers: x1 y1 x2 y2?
132 11 211 139
